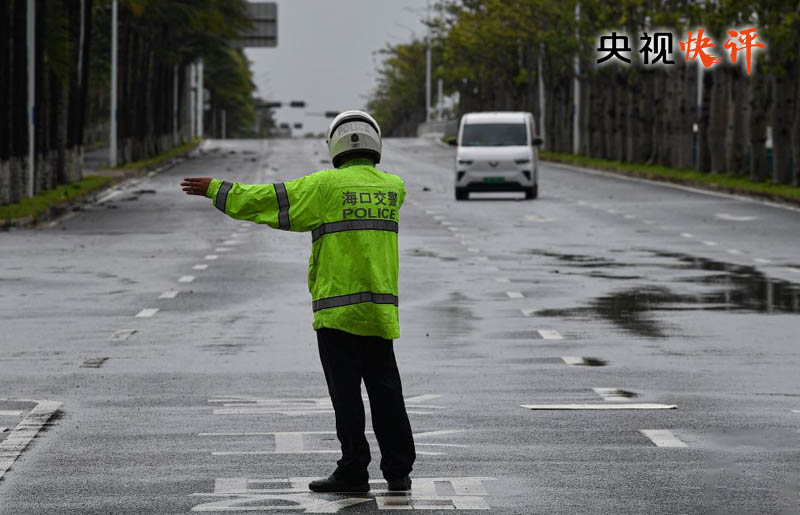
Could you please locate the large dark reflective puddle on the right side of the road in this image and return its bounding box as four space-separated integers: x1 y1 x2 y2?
526 250 800 338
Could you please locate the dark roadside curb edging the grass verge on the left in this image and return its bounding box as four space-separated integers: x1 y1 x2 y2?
0 142 202 231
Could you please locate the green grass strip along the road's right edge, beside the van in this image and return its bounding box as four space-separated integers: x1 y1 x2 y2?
539 151 800 204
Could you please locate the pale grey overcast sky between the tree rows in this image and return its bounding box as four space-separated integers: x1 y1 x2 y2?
245 0 428 133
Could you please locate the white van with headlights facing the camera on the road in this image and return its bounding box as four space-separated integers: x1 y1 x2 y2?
454 112 542 200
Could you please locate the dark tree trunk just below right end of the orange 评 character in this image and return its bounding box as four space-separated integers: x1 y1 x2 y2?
749 59 772 182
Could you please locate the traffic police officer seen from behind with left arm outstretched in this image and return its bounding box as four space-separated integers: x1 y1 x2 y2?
181 111 416 492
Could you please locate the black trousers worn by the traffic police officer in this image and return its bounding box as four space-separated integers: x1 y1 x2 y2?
317 329 416 482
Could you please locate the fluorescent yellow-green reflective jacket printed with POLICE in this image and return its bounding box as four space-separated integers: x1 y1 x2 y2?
206 159 405 340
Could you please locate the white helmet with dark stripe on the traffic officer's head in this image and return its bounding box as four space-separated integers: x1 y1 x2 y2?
328 110 381 168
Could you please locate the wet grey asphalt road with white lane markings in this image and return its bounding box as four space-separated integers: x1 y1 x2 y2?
0 139 800 515
